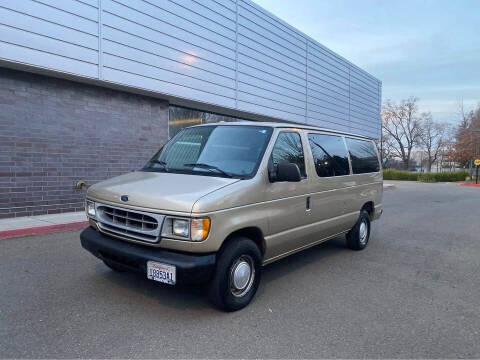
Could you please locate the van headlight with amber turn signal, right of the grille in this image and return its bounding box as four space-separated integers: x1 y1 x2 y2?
162 216 210 241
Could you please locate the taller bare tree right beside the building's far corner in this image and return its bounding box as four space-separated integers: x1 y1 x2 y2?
382 97 422 170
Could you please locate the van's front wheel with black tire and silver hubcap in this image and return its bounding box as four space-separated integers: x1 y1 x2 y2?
209 237 262 311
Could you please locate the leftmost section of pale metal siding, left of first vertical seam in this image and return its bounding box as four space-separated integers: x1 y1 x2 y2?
0 0 99 78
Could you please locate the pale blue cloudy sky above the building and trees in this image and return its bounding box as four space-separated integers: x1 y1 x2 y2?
254 0 480 123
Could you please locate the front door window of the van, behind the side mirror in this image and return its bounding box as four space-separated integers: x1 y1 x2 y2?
272 132 306 176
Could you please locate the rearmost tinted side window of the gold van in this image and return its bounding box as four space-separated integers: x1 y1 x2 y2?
346 138 380 174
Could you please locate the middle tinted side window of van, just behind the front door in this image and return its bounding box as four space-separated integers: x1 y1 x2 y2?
308 134 350 177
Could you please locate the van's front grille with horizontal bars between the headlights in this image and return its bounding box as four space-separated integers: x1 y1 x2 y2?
96 203 165 243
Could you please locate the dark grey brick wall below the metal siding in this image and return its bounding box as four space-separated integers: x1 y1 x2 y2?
0 68 168 218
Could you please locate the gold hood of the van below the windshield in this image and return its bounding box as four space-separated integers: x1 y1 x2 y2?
87 171 239 212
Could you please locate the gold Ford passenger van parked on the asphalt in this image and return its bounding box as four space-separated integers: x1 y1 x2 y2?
80 122 383 311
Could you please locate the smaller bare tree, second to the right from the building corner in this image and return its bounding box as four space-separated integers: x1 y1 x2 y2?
419 113 449 172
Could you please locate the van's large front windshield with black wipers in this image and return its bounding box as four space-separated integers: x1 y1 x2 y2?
143 125 272 178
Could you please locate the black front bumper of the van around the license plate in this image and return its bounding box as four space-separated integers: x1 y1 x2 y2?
80 227 216 284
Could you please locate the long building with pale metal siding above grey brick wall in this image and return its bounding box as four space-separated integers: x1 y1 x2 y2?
0 0 381 218
